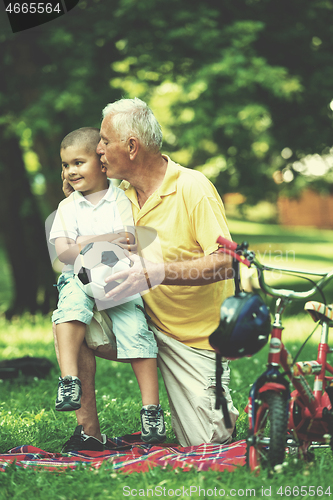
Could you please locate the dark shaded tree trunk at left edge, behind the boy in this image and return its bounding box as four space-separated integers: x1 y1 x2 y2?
0 126 57 318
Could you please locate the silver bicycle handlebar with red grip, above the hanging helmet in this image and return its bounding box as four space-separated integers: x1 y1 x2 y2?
217 236 333 300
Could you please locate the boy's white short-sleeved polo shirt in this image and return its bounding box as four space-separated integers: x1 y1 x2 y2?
49 179 134 272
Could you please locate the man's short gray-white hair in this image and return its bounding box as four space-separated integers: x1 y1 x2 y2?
102 97 162 153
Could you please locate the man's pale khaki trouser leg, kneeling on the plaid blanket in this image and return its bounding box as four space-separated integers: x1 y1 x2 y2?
150 325 239 446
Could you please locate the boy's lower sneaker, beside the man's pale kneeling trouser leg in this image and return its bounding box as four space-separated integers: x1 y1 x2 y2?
140 405 166 443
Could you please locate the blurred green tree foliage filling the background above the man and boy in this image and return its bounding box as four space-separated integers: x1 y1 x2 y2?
0 0 333 312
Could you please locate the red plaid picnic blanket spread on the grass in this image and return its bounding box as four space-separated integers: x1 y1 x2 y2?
0 433 246 474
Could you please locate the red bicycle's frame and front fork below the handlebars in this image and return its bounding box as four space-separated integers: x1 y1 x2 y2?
247 298 333 443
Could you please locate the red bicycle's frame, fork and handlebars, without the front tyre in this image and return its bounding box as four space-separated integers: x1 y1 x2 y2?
217 238 333 468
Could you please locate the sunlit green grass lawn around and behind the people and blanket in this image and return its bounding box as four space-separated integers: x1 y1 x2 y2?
0 221 333 500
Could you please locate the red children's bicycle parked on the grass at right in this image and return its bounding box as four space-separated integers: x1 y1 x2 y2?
218 237 333 470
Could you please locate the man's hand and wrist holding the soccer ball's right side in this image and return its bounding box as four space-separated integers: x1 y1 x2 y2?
105 255 165 301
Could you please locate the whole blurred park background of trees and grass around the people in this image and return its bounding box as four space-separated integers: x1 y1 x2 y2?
0 0 333 499
